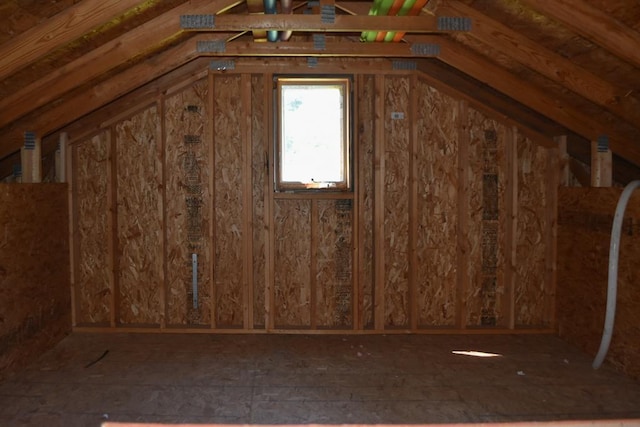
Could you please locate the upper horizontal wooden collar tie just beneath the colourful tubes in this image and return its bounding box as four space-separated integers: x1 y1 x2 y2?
185 13 451 34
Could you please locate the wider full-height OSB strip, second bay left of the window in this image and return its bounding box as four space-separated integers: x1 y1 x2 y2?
213 75 245 327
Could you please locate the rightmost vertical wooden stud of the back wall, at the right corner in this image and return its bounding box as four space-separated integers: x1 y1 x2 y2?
543 148 568 328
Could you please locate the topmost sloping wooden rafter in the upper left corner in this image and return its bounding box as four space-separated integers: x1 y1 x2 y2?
0 0 145 79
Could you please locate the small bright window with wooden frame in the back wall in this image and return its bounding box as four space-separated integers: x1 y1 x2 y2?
275 77 351 191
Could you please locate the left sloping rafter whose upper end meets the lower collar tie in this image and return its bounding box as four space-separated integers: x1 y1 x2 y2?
0 36 206 159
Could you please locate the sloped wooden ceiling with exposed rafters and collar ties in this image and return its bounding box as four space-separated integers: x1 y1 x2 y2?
0 0 640 183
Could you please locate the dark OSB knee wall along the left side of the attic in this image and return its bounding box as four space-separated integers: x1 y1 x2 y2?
0 184 71 379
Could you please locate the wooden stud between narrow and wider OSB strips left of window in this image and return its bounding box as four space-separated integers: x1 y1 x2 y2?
241 73 253 329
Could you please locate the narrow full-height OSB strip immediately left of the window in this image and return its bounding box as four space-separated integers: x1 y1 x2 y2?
251 74 268 327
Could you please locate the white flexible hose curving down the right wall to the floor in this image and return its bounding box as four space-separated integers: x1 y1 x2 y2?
592 181 640 369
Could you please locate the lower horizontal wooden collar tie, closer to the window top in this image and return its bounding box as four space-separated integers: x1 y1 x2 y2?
200 39 436 58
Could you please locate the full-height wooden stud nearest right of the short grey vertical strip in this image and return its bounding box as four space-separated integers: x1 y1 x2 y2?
211 71 217 329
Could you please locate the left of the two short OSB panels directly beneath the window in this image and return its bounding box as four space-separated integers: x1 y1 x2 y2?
273 200 311 327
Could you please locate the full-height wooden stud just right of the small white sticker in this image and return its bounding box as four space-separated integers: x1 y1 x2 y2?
409 73 418 331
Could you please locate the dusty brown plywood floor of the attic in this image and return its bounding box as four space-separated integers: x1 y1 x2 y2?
0 333 640 427
